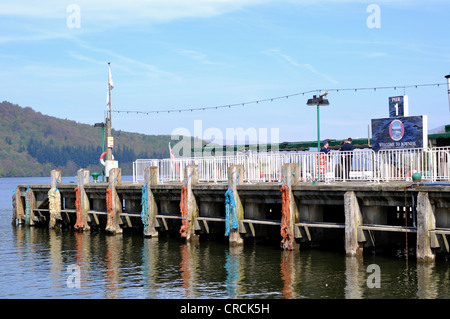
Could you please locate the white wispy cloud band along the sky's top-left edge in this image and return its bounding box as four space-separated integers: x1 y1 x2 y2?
0 0 268 25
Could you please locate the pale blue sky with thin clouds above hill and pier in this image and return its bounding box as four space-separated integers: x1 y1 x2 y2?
0 0 450 147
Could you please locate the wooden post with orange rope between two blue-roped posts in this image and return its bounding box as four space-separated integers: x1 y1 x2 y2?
183 165 199 242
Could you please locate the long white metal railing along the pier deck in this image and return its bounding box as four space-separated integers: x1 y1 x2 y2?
133 147 450 183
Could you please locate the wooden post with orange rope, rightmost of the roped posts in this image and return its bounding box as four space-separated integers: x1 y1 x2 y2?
280 163 300 250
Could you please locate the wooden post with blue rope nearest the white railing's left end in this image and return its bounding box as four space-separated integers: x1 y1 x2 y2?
143 166 158 237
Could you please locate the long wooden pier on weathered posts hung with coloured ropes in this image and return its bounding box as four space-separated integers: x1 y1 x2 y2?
12 152 450 262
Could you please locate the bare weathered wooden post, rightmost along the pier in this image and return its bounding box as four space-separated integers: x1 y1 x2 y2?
416 192 436 262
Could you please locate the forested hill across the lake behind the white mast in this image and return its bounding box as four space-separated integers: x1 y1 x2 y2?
0 101 175 177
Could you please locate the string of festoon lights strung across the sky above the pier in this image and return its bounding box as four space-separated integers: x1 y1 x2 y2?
111 83 447 115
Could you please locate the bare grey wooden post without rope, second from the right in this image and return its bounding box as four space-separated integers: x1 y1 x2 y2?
344 191 363 256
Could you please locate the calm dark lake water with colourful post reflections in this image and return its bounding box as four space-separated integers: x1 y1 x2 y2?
0 177 450 299
